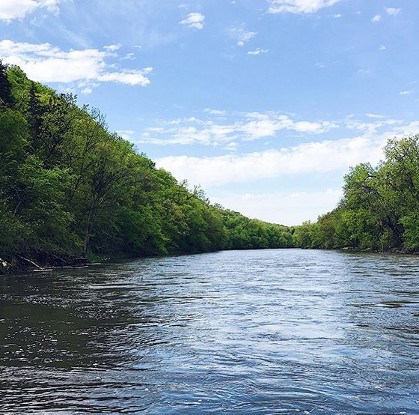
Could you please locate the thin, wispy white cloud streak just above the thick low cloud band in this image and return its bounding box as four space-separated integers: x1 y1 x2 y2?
139 111 337 146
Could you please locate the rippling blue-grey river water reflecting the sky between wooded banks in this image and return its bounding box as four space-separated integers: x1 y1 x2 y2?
0 249 419 414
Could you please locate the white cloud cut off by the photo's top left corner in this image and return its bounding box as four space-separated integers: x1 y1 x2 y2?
0 0 61 21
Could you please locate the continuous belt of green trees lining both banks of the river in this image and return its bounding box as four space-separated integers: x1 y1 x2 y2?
0 60 419 274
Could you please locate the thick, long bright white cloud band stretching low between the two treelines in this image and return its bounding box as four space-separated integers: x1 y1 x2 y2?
156 134 387 188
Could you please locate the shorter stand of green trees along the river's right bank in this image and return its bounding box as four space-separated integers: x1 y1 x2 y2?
294 135 419 252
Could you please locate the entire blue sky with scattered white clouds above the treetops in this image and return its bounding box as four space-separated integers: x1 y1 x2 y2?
0 0 419 225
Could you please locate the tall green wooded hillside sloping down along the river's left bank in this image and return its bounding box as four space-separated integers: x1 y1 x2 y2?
0 61 293 272
